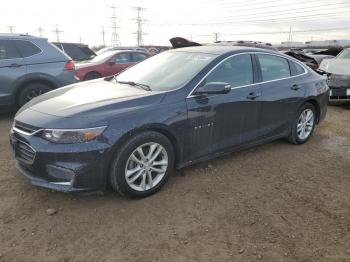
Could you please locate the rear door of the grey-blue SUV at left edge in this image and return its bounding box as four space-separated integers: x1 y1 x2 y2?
0 40 26 104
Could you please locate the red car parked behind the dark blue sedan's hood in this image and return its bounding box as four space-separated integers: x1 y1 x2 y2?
75 50 150 81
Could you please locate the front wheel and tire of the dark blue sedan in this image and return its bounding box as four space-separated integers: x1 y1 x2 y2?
109 131 174 198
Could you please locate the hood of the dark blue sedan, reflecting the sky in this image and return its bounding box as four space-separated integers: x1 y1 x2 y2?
17 79 164 119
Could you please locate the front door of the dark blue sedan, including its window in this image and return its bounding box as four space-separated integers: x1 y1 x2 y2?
187 54 261 160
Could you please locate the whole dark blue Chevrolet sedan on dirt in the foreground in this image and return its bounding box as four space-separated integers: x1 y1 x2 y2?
10 46 329 197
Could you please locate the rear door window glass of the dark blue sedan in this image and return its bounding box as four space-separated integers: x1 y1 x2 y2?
257 55 290 81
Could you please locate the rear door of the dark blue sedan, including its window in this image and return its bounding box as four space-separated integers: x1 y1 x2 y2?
256 54 306 138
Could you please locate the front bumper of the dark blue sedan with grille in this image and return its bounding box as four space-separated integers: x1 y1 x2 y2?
10 128 109 193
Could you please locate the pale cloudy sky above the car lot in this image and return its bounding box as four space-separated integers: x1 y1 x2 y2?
0 0 350 46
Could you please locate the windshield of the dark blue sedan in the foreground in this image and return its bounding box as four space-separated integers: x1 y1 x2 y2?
117 52 217 91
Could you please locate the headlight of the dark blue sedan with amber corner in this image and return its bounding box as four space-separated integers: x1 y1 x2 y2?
41 126 106 144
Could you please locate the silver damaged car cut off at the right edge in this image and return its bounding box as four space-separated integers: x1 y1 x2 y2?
320 48 350 101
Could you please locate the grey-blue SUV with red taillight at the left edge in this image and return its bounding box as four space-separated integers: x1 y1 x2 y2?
0 34 77 106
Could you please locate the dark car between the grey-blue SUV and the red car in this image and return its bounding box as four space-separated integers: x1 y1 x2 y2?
53 42 96 61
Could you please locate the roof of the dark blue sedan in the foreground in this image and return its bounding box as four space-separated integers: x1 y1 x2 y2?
173 45 276 55
